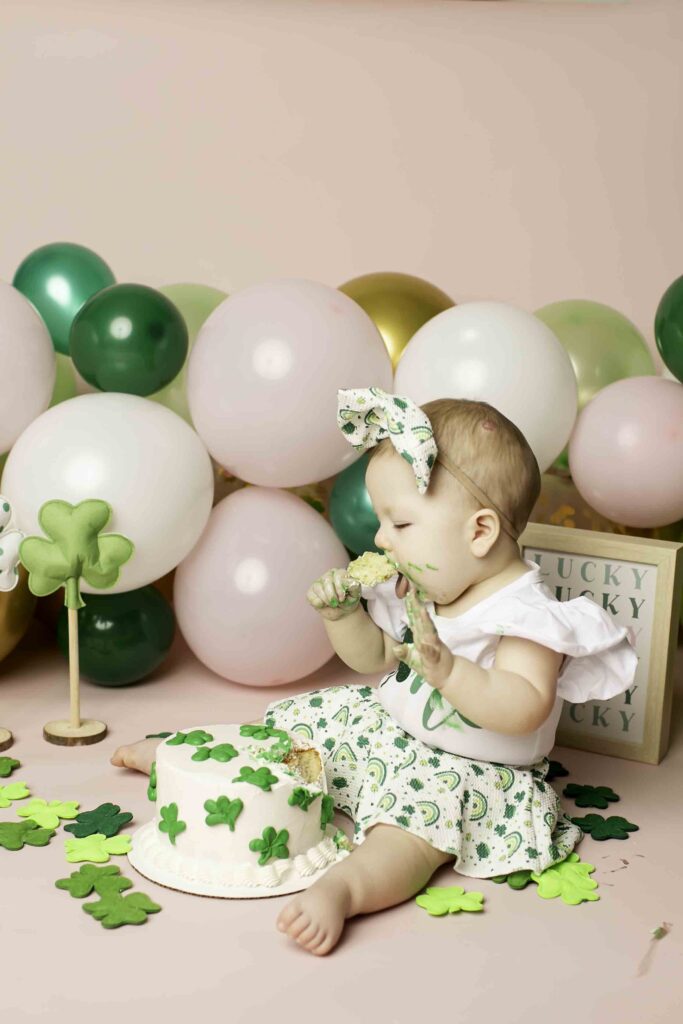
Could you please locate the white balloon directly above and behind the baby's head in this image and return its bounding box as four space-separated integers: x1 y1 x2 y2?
393 302 579 473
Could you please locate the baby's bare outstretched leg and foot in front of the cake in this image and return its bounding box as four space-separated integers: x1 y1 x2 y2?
278 823 455 956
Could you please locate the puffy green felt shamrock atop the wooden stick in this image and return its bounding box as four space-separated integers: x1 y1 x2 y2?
19 498 135 608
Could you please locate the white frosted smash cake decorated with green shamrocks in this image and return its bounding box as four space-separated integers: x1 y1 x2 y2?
128 725 350 896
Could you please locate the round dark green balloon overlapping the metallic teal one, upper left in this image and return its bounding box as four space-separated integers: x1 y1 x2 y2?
69 285 187 395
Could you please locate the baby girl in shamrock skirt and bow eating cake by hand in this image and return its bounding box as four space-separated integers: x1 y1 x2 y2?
112 387 637 955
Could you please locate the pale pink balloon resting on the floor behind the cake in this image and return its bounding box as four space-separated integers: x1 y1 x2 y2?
173 486 349 686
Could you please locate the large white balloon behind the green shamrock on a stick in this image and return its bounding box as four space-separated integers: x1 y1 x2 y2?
1 391 213 594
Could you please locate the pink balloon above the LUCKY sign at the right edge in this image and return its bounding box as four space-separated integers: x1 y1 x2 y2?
569 377 683 526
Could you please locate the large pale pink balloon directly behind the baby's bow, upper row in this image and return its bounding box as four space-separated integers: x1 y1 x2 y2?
187 279 393 487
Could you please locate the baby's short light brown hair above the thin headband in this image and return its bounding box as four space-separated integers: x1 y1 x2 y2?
369 398 541 534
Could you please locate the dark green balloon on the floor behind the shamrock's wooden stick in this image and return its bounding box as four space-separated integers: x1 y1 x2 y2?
57 586 175 686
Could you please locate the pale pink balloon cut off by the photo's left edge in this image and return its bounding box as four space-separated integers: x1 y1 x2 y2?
0 281 57 452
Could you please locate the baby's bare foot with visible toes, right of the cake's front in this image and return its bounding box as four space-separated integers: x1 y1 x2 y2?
276 872 351 956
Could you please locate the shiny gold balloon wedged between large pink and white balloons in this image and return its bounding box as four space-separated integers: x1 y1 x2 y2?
339 272 456 370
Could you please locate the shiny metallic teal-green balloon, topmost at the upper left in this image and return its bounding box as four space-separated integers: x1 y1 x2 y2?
12 242 116 355
